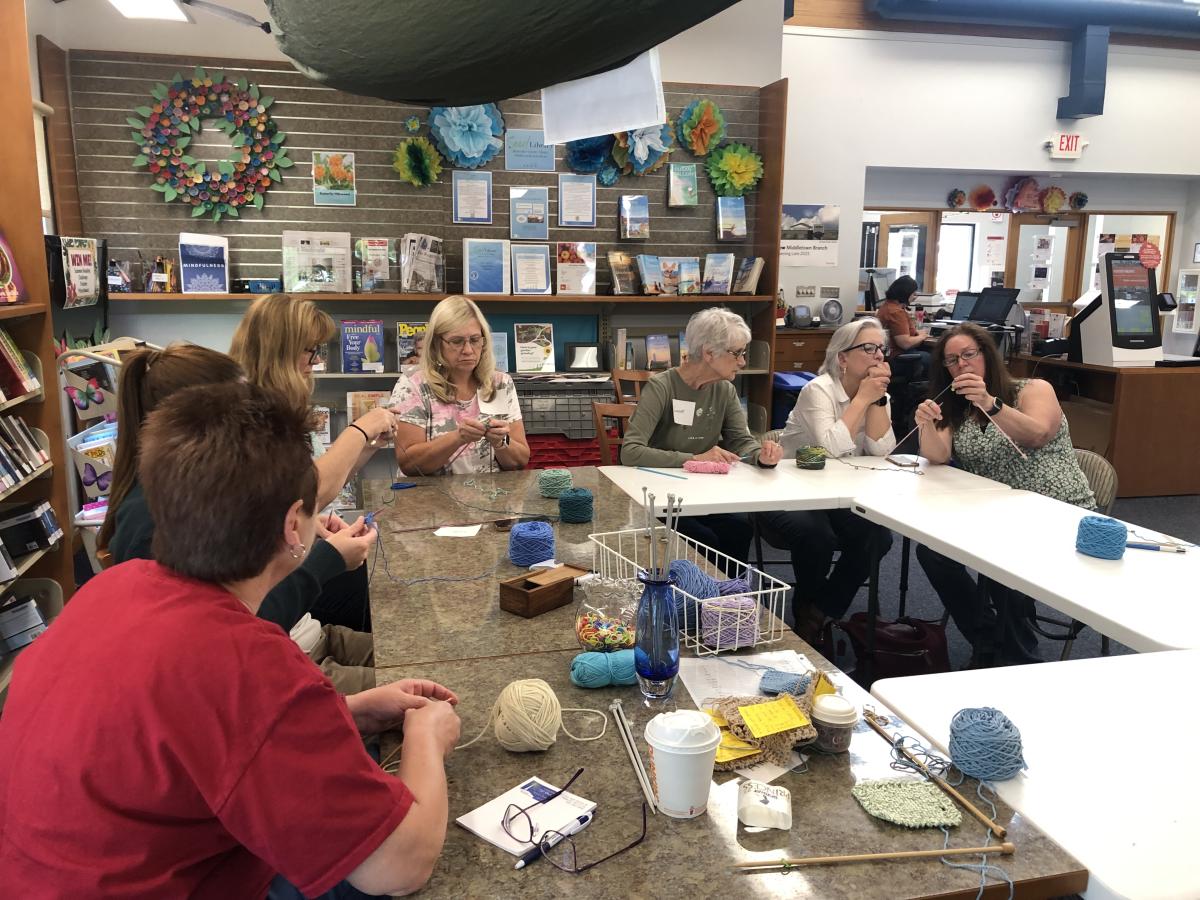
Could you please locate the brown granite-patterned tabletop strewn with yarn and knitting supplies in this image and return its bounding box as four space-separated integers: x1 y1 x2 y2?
366 469 1087 900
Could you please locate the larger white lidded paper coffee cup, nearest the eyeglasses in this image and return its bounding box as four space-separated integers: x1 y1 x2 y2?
646 709 721 818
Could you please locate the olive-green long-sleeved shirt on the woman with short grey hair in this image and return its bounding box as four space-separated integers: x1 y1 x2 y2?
620 368 761 467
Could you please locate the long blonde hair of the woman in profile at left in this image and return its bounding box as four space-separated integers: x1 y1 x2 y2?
229 294 337 409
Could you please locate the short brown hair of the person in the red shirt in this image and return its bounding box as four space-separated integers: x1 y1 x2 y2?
138 382 317 583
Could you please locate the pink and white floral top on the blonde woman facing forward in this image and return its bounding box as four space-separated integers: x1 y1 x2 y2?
389 368 521 475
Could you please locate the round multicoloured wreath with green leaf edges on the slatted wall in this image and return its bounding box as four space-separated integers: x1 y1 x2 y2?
126 66 294 222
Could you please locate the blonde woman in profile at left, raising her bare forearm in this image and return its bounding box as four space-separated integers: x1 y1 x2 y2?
229 294 396 631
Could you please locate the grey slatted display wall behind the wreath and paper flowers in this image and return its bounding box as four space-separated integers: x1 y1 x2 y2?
70 50 758 294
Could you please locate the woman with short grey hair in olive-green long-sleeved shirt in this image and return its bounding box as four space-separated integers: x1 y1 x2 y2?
620 307 784 568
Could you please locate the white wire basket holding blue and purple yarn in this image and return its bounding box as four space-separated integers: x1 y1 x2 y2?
589 526 788 656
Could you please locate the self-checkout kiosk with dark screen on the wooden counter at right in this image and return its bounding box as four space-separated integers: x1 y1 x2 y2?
1067 253 1163 366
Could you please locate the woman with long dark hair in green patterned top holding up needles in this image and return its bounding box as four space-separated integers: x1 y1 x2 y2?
916 323 1096 662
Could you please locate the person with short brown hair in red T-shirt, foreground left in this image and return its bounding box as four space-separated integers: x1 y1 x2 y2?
0 382 460 898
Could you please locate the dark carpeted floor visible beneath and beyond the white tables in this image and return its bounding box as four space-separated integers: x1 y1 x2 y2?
763 494 1200 668
